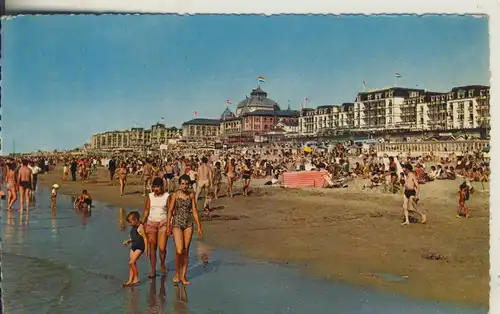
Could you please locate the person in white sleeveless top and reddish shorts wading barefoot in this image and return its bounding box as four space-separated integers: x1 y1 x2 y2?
142 177 169 278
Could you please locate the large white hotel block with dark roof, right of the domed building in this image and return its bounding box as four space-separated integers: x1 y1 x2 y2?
299 85 490 135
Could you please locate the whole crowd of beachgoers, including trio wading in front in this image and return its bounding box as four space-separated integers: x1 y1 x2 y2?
0 143 490 286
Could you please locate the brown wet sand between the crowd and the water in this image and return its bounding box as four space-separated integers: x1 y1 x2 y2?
38 168 489 306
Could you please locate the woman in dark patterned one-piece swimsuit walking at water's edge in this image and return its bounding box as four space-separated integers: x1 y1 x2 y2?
167 174 203 285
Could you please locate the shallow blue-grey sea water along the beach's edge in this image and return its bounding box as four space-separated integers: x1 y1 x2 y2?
1 189 487 314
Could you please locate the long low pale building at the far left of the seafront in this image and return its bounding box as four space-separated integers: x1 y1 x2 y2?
90 123 180 150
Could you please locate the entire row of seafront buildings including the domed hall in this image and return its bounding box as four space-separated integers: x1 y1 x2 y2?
91 85 490 150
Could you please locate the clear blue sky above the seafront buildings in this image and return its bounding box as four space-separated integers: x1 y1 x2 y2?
2 15 490 153
